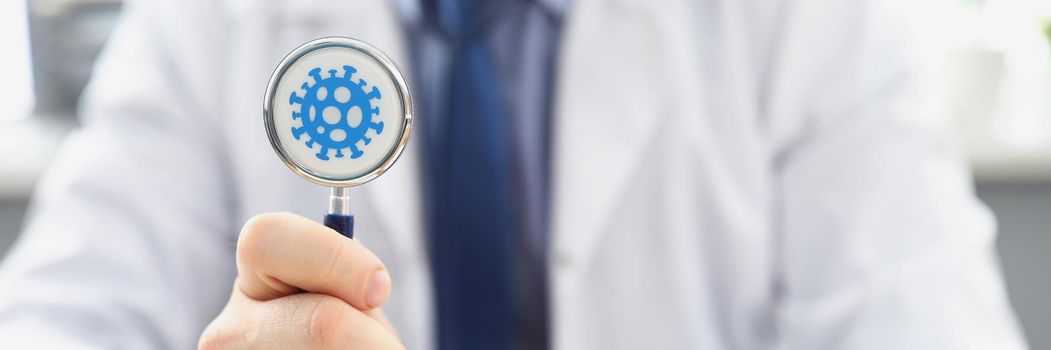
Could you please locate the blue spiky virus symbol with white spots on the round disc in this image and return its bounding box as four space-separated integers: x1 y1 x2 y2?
288 65 384 161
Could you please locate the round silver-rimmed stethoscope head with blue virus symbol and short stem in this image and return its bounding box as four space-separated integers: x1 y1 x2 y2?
263 37 412 238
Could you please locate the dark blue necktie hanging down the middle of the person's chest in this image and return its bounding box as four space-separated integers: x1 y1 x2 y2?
424 0 516 349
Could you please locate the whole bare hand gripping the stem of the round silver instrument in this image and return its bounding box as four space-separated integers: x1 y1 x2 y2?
198 213 403 349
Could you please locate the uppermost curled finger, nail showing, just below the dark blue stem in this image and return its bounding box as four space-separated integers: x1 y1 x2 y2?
238 213 391 310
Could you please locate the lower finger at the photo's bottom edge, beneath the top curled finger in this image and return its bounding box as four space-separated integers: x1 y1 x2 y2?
199 293 403 349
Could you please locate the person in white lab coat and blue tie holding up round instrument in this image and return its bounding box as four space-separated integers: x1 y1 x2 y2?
0 0 1025 349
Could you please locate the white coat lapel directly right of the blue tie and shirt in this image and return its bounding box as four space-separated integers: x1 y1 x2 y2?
552 0 668 275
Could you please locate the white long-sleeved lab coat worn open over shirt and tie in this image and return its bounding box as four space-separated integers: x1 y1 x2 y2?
0 0 1025 349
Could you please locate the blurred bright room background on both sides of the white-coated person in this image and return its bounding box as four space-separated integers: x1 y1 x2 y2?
0 0 1051 349
